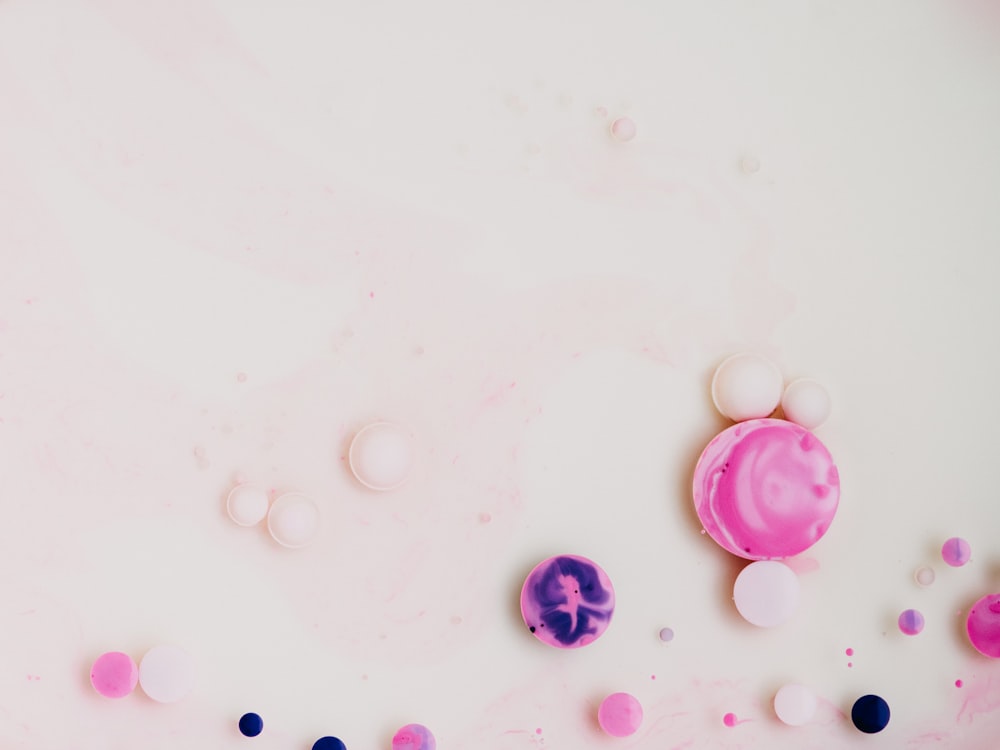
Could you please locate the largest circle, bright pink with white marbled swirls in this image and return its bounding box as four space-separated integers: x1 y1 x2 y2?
694 419 840 560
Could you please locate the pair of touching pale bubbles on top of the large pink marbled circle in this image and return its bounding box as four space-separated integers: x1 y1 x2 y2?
712 353 830 430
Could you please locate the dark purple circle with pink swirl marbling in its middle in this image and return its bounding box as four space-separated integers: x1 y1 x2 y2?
521 555 615 648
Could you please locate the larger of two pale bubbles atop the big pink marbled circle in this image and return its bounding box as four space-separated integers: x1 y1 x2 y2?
712 353 782 422
